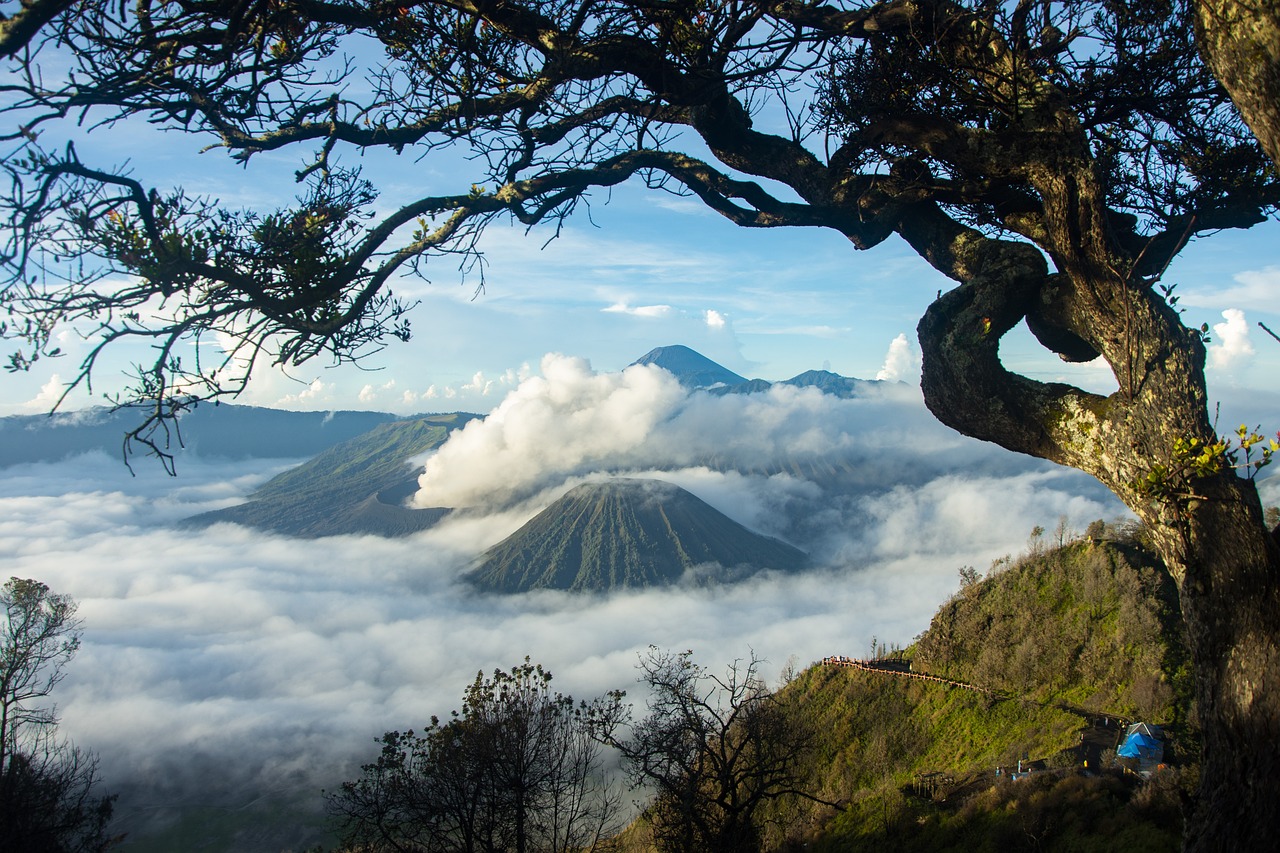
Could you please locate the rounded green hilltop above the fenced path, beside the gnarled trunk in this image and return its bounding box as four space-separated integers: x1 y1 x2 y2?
914 539 1192 724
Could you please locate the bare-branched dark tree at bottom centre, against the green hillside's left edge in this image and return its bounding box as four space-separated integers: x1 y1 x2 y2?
605 647 817 853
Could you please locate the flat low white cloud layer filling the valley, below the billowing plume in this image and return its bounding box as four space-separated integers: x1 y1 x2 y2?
0 440 1114 829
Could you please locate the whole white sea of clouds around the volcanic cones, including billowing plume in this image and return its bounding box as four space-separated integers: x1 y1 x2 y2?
0 356 1280 840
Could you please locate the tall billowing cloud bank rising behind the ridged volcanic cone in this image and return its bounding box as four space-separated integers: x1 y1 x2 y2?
415 355 1117 566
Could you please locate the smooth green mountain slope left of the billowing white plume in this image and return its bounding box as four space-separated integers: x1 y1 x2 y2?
188 412 476 537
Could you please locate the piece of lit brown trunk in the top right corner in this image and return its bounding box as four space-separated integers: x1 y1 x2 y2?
1196 0 1280 164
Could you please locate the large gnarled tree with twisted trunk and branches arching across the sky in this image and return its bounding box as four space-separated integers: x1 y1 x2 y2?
0 0 1280 849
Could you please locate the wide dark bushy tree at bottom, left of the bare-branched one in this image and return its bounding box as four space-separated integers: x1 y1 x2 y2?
328 658 622 853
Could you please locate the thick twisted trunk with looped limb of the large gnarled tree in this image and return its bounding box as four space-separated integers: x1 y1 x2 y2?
909 216 1280 853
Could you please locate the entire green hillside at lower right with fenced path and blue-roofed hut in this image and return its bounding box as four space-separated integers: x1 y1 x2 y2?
771 539 1198 852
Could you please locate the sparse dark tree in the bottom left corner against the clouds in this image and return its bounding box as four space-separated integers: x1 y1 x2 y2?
0 578 115 853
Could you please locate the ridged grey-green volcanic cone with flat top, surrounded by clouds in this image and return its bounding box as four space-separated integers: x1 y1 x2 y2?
468 478 808 593
